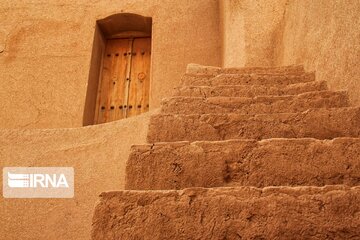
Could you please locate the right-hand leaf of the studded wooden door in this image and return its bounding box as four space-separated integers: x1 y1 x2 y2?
127 38 151 117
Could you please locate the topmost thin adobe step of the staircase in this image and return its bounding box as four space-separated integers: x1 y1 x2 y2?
186 63 305 76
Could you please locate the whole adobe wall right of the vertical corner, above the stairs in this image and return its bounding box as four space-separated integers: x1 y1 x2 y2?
220 0 360 104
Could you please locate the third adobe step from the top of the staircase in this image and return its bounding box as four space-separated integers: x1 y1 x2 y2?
173 81 327 97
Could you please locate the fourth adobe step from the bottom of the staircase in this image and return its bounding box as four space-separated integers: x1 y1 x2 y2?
161 91 349 114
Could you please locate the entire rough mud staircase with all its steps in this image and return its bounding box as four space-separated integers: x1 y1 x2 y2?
92 65 360 239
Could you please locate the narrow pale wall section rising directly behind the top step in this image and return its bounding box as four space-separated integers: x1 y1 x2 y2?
219 0 286 67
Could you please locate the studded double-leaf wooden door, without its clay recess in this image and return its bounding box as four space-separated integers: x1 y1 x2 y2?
94 38 151 124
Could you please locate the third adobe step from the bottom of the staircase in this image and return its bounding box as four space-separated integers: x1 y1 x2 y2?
148 107 360 143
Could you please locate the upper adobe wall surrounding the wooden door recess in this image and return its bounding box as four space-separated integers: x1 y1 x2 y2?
0 0 221 129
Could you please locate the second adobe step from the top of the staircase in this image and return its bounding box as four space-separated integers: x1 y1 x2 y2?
181 73 315 86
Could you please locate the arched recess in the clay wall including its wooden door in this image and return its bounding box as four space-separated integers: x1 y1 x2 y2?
83 13 152 126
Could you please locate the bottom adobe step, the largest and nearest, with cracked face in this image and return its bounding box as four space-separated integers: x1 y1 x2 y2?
92 186 360 240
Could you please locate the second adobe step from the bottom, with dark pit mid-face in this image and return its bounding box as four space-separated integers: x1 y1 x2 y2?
125 138 360 190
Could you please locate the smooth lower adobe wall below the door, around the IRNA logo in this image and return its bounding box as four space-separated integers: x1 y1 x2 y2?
0 113 151 240
